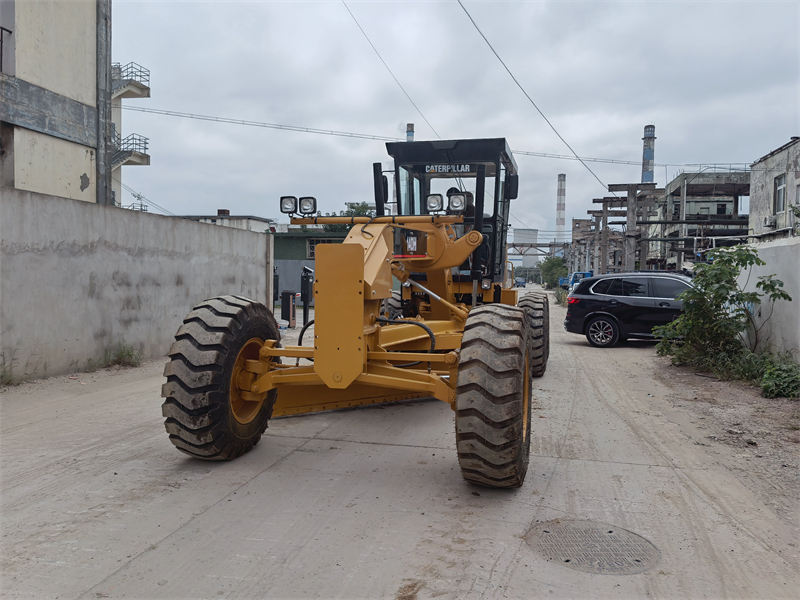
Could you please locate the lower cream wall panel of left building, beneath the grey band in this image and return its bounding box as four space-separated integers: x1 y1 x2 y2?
14 127 97 202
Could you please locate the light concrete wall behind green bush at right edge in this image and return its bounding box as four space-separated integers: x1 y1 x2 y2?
739 237 800 360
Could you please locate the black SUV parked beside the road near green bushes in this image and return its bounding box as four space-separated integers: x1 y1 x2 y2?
564 271 692 348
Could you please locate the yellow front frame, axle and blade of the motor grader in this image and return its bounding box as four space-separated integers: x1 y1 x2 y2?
236 217 482 416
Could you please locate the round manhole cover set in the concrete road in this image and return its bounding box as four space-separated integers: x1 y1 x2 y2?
525 519 661 575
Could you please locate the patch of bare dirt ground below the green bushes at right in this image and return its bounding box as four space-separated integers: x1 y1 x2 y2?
654 357 800 526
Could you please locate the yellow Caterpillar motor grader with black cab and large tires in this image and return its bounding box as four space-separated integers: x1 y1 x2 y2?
162 138 549 487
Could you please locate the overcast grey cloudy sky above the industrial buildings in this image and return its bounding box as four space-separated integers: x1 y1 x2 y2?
112 0 800 239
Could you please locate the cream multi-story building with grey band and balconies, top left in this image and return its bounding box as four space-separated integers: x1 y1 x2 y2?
0 0 149 205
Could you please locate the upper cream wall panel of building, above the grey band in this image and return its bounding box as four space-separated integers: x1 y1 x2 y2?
13 0 97 106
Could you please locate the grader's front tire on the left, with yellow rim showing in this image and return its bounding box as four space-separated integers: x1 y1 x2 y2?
161 296 280 460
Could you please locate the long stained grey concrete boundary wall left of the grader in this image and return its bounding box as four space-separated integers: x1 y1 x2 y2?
0 188 272 377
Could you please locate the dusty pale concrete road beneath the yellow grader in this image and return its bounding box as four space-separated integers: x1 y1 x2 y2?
0 292 800 600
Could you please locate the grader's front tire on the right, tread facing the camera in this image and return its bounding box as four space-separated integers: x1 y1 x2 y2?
456 304 531 488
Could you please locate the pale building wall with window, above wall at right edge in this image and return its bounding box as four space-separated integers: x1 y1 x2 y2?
750 141 800 235
